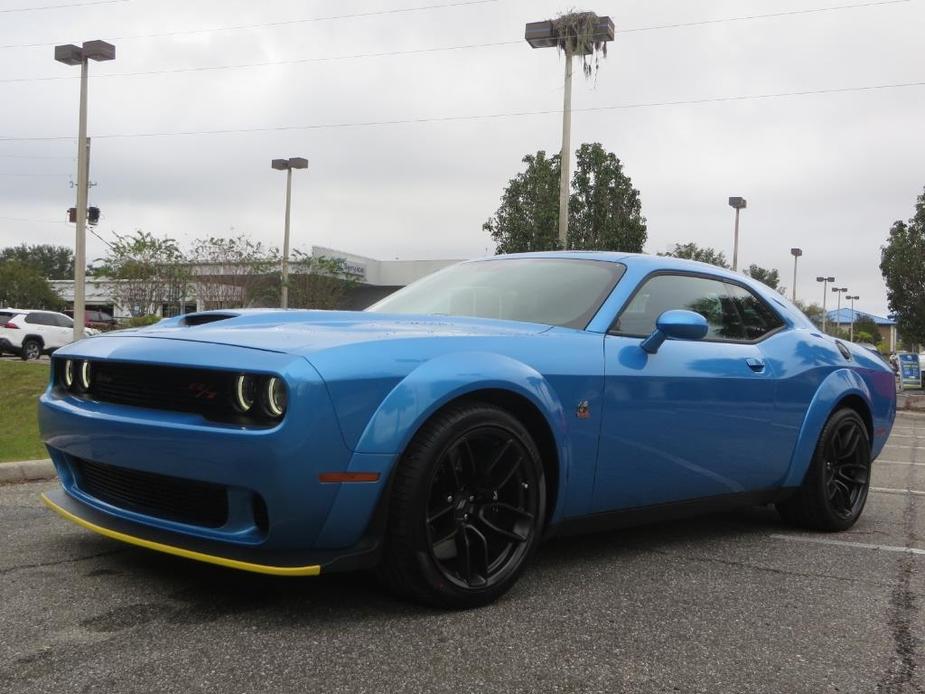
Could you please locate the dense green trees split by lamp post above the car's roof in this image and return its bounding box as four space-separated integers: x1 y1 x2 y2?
482 143 646 253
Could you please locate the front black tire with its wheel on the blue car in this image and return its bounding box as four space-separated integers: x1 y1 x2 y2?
379 402 546 609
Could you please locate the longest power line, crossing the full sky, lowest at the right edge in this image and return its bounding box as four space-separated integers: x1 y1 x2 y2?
0 81 925 142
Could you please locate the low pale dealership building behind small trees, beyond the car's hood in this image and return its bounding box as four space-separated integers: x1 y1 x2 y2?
49 246 460 318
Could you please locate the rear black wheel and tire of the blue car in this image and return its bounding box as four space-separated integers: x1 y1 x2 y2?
777 408 870 532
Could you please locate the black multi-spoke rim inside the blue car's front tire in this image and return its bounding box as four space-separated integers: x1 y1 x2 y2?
425 426 539 589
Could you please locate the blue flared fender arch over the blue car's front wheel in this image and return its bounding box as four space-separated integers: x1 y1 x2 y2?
356 351 571 520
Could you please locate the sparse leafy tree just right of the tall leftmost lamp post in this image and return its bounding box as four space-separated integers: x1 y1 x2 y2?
93 230 190 318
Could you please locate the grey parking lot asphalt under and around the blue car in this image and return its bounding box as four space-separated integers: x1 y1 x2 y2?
0 415 925 694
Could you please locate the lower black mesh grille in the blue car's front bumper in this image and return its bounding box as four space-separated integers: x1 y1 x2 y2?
72 459 228 528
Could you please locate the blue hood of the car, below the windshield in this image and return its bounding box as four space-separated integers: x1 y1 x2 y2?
93 310 550 356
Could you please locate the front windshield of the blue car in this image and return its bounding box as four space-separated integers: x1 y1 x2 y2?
366 258 626 328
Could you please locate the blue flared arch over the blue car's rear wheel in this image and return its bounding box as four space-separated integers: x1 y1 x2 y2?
783 369 874 487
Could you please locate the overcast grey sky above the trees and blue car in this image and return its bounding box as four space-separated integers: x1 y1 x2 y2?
0 0 925 314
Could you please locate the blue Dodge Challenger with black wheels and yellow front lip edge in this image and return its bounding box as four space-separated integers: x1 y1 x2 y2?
40 252 896 607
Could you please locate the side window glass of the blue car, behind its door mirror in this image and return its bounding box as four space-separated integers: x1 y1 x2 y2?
611 275 783 342
